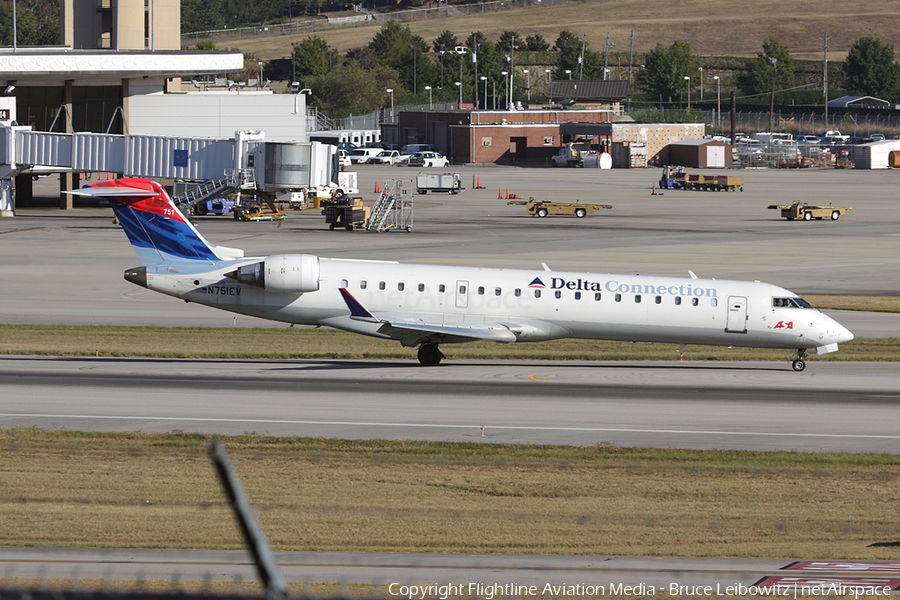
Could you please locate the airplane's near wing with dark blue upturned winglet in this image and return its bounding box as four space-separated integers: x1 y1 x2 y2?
340 288 518 346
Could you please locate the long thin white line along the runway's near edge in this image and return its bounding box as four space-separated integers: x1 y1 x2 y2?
0 413 900 440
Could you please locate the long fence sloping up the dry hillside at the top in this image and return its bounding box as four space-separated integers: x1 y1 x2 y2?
181 0 584 48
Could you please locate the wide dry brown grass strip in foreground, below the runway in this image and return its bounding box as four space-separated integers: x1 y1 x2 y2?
0 428 900 560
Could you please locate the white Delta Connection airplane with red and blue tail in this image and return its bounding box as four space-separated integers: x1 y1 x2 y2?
72 179 853 371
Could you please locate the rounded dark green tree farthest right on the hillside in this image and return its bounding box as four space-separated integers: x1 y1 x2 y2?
843 37 900 98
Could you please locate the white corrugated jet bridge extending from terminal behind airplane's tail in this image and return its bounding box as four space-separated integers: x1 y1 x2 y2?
0 125 340 216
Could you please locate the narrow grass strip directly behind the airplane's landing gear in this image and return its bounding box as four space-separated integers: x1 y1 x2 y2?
0 325 900 361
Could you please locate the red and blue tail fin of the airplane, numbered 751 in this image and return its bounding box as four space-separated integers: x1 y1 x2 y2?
69 178 244 265
